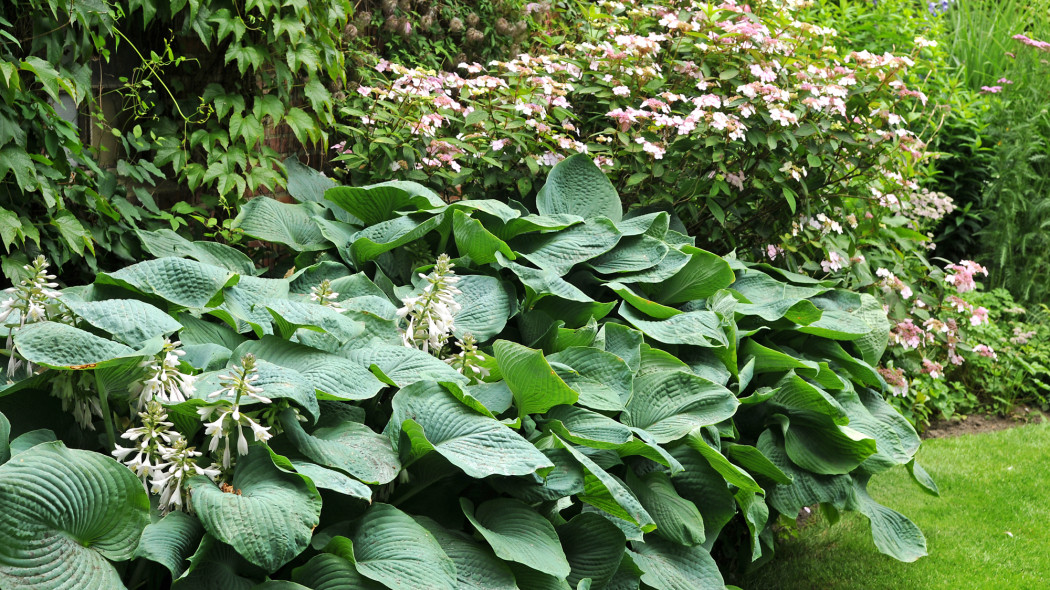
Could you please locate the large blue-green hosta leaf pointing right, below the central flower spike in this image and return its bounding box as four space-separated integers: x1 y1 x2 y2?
386 381 553 479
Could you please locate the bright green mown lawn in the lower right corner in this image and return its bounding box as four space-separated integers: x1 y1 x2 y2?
741 423 1050 590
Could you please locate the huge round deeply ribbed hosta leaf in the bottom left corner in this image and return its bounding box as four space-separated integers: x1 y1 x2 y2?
0 442 149 590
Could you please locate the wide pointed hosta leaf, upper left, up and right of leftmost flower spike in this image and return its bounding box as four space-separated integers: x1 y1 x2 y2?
95 258 240 308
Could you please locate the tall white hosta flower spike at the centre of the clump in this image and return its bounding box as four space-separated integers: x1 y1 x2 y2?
397 254 462 356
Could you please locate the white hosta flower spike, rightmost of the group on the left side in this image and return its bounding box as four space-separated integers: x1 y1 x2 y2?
197 354 273 470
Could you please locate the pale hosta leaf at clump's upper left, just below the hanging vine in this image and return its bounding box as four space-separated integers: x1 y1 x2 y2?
233 196 332 252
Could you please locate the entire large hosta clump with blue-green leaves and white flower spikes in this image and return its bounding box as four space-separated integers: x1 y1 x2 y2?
0 156 936 590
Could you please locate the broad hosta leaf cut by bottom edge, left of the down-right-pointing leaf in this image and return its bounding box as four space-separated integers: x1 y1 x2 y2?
339 504 457 590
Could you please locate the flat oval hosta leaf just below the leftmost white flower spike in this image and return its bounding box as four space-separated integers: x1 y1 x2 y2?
15 321 137 368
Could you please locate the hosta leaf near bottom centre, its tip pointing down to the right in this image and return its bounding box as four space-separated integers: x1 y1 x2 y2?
460 498 571 577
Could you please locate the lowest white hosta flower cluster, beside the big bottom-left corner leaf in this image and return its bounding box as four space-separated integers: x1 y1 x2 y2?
112 400 219 514
